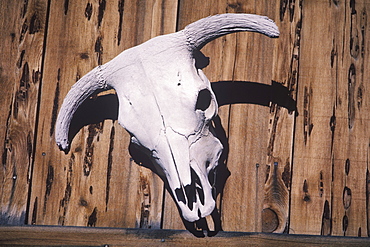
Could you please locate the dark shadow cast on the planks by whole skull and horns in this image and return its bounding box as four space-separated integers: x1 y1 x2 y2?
69 80 298 237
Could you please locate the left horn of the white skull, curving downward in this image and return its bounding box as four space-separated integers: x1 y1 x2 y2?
55 66 109 152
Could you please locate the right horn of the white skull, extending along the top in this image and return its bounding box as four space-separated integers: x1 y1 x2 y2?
184 14 280 50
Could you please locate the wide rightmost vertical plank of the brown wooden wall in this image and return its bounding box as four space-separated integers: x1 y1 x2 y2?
290 1 369 236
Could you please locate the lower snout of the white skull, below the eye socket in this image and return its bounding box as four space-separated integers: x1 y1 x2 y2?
156 125 222 222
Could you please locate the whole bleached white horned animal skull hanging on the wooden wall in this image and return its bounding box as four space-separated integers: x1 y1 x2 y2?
55 14 279 222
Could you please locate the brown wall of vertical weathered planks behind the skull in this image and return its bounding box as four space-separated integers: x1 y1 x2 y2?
0 0 370 236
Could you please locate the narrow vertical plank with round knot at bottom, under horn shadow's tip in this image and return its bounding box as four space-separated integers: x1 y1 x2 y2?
262 1 302 233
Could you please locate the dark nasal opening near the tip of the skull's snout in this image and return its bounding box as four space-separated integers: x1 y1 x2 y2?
175 168 204 210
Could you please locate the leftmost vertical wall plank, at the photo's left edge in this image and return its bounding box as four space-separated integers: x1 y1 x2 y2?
0 0 47 225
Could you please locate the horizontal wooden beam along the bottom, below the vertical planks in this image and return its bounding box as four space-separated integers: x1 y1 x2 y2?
0 226 370 246
